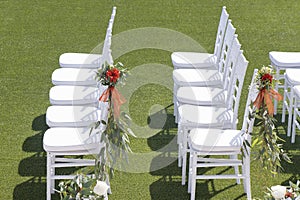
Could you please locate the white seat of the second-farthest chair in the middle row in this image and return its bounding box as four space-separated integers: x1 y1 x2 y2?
173 69 222 87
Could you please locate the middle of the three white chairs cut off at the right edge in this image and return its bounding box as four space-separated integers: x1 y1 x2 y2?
281 68 300 136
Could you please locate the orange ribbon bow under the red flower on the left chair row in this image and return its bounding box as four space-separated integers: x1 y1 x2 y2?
99 86 126 118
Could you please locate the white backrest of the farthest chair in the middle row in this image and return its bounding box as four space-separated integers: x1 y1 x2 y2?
214 6 229 62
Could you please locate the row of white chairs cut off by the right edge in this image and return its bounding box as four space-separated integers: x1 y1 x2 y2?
269 51 300 143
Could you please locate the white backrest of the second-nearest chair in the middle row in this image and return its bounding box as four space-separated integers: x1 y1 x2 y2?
228 51 248 129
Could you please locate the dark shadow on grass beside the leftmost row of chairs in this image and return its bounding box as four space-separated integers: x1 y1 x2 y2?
13 114 75 200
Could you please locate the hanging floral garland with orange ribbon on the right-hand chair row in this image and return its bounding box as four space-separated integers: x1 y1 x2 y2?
252 66 291 174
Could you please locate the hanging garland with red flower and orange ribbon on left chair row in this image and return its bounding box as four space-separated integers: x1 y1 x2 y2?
93 62 135 180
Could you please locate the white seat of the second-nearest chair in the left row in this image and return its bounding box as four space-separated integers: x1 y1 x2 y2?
46 106 101 127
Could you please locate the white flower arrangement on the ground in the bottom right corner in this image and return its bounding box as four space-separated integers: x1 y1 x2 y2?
265 180 300 200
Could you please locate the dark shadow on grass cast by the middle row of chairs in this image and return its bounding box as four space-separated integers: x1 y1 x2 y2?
148 105 245 200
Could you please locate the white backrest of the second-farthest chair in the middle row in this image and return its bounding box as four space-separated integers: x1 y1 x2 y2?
218 20 237 75
